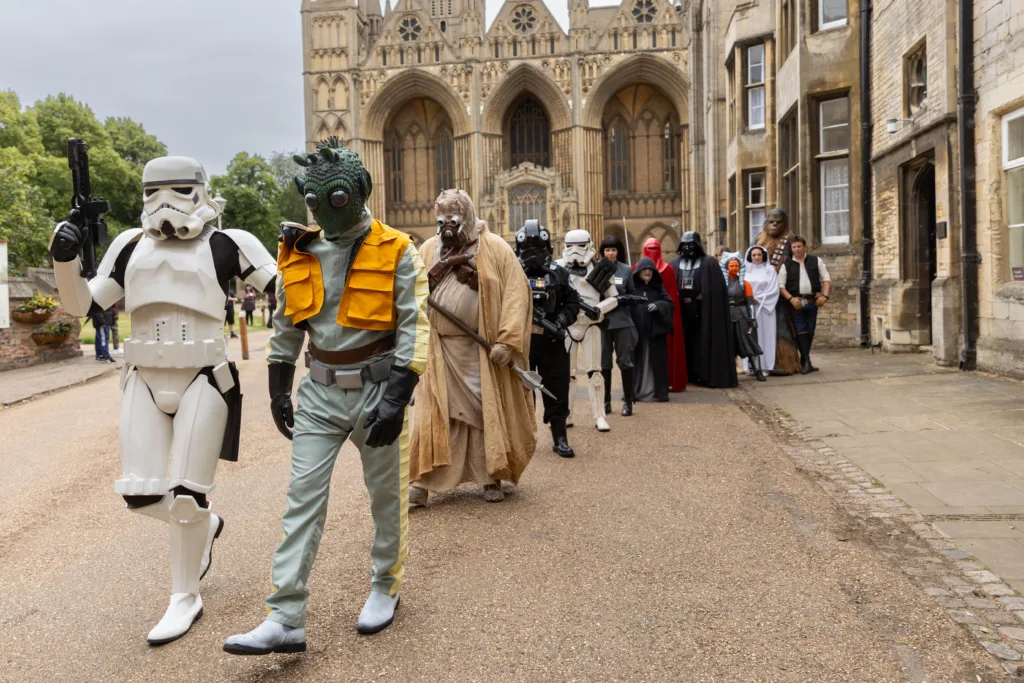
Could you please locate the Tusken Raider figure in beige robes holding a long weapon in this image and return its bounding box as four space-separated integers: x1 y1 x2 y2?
411 189 537 504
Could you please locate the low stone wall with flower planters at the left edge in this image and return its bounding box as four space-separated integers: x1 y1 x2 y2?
0 268 82 371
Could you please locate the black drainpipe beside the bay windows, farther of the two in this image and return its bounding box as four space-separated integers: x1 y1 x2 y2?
860 0 874 348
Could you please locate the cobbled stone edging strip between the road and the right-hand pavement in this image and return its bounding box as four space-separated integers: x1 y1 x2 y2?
727 385 1024 677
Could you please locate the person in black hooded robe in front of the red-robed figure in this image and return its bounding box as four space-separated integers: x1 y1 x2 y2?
630 256 678 402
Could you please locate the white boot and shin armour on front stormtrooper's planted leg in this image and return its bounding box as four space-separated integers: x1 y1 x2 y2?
146 496 212 645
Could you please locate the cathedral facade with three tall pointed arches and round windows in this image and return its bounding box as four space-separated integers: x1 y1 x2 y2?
302 0 703 256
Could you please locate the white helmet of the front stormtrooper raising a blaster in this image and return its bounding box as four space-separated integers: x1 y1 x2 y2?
142 157 220 240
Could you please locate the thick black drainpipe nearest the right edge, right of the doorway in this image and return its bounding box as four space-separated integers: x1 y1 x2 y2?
956 0 981 370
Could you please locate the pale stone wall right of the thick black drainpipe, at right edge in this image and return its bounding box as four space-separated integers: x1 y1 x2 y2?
974 0 1024 377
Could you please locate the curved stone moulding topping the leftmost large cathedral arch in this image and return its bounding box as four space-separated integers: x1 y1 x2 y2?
362 69 470 140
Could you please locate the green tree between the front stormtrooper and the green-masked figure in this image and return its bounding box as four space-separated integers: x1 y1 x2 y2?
210 152 282 253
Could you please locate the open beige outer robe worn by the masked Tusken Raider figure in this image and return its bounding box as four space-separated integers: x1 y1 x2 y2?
410 226 537 483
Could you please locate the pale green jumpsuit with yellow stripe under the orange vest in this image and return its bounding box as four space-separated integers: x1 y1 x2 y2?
266 218 429 628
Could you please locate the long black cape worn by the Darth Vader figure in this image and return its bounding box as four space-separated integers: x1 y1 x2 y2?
670 255 739 389
